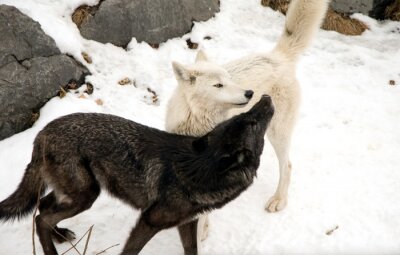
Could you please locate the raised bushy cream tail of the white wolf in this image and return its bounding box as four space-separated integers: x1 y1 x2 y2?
274 0 329 61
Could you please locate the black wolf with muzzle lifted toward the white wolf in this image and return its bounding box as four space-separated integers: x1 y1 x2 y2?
0 96 274 255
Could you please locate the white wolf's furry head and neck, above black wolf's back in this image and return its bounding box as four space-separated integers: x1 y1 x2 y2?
166 61 249 136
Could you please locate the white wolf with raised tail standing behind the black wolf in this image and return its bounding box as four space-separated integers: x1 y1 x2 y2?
166 0 329 239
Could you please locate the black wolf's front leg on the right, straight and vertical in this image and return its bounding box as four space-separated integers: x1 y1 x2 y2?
178 219 200 255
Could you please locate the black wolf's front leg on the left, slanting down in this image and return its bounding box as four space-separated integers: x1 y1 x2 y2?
121 216 160 255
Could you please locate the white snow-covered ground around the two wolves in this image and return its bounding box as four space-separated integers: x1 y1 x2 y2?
0 0 400 255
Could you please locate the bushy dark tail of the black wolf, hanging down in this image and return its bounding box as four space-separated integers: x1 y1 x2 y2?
0 146 45 221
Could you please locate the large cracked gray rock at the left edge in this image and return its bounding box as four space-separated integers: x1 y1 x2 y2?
0 5 88 140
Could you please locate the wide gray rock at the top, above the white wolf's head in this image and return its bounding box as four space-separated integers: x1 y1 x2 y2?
80 0 219 47
